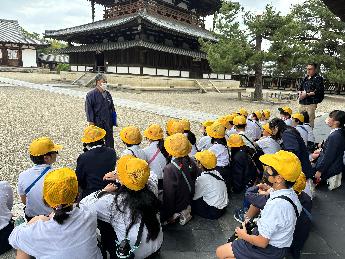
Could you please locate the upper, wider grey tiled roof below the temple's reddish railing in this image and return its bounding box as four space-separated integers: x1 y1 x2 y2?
45 12 217 41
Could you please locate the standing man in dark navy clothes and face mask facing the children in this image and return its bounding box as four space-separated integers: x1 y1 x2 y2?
85 74 117 148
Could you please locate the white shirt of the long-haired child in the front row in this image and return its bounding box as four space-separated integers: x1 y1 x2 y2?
79 175 163 259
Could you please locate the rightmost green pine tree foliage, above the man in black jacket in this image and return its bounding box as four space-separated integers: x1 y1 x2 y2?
270 0 345 84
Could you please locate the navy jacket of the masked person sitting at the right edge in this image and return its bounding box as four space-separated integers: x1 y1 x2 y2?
315 129 345 180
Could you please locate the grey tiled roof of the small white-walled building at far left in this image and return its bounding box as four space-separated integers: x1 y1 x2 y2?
0 19 48 46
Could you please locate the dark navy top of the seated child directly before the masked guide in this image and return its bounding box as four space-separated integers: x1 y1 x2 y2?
76 146 116 198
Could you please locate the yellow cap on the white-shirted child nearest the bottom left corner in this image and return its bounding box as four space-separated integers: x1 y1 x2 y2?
43 168 78 208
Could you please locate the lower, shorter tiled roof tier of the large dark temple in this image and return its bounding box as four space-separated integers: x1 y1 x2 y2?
52 40 206 59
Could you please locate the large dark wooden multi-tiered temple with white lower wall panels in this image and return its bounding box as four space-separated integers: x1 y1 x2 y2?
45 0 221 78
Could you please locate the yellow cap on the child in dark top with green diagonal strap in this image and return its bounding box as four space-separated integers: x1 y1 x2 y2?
164 133 192 158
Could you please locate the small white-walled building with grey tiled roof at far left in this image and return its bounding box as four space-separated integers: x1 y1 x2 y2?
0 19 48 67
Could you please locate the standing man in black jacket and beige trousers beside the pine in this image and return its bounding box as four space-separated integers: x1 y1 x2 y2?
298 63 325 128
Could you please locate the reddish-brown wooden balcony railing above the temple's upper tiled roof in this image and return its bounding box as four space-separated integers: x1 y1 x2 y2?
103 0 205 28
